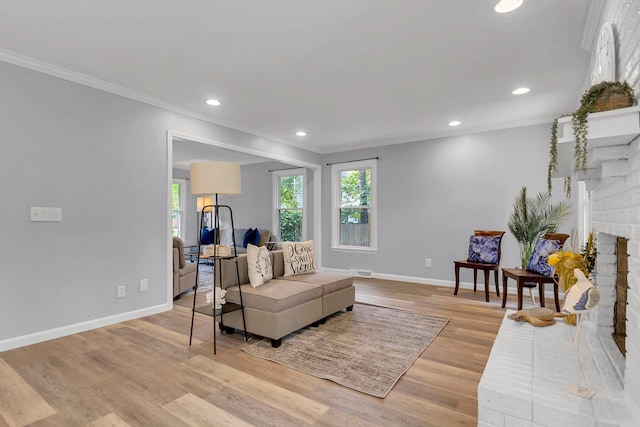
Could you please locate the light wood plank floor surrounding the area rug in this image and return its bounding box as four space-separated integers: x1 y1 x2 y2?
0 279 544 427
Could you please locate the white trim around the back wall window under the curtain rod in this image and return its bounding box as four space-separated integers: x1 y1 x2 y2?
331 159 378 253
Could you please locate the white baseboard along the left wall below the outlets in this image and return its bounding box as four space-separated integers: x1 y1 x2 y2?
0 301 173 352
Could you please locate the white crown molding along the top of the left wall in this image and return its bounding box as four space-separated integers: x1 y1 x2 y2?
0 49 320 154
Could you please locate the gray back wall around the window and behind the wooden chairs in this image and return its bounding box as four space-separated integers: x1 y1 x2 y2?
322 125 577 281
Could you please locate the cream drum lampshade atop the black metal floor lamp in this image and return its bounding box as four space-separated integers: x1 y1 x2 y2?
191 162 241 196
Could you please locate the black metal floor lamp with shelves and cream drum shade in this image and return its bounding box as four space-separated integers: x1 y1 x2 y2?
189 162 247 354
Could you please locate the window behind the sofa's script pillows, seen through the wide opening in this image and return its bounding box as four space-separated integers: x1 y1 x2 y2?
273 169 306 242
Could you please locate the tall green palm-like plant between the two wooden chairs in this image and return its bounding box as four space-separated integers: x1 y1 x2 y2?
507 187 571 269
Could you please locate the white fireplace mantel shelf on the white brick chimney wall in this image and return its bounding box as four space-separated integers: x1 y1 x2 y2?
552 106 640 187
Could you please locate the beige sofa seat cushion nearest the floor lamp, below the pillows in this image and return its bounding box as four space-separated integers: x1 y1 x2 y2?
226 279 322 313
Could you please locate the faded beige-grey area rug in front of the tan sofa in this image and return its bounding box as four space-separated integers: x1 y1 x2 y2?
244 304 449 398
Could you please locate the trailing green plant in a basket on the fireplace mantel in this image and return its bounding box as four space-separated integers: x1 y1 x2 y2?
547 81 634 199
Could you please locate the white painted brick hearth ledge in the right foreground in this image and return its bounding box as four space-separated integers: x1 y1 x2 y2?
478 310 630 427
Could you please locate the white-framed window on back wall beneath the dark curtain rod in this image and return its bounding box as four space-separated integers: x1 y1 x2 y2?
331 160 377 251
